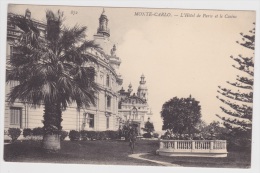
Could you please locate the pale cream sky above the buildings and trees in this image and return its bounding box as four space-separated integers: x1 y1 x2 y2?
9 5 255 131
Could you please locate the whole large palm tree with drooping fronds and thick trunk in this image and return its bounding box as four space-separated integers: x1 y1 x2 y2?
6 10 99 150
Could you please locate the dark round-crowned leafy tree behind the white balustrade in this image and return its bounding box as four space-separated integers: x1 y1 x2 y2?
161 96 201 136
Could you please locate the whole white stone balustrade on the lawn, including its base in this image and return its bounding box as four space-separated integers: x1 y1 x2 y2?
157 140 228 157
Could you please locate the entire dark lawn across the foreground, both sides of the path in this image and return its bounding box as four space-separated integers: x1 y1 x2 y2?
4 140 250 168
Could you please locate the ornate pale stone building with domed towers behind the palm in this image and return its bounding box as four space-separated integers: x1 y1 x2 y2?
4 9 151 133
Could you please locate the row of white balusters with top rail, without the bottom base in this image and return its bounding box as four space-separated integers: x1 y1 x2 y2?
159 140 227 153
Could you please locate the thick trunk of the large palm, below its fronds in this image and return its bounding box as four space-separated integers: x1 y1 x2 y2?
42 102 62 151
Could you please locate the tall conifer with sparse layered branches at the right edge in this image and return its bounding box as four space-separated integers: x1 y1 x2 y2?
217 23 255 149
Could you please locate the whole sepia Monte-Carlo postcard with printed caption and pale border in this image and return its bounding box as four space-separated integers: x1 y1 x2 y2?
1 3 259 171
